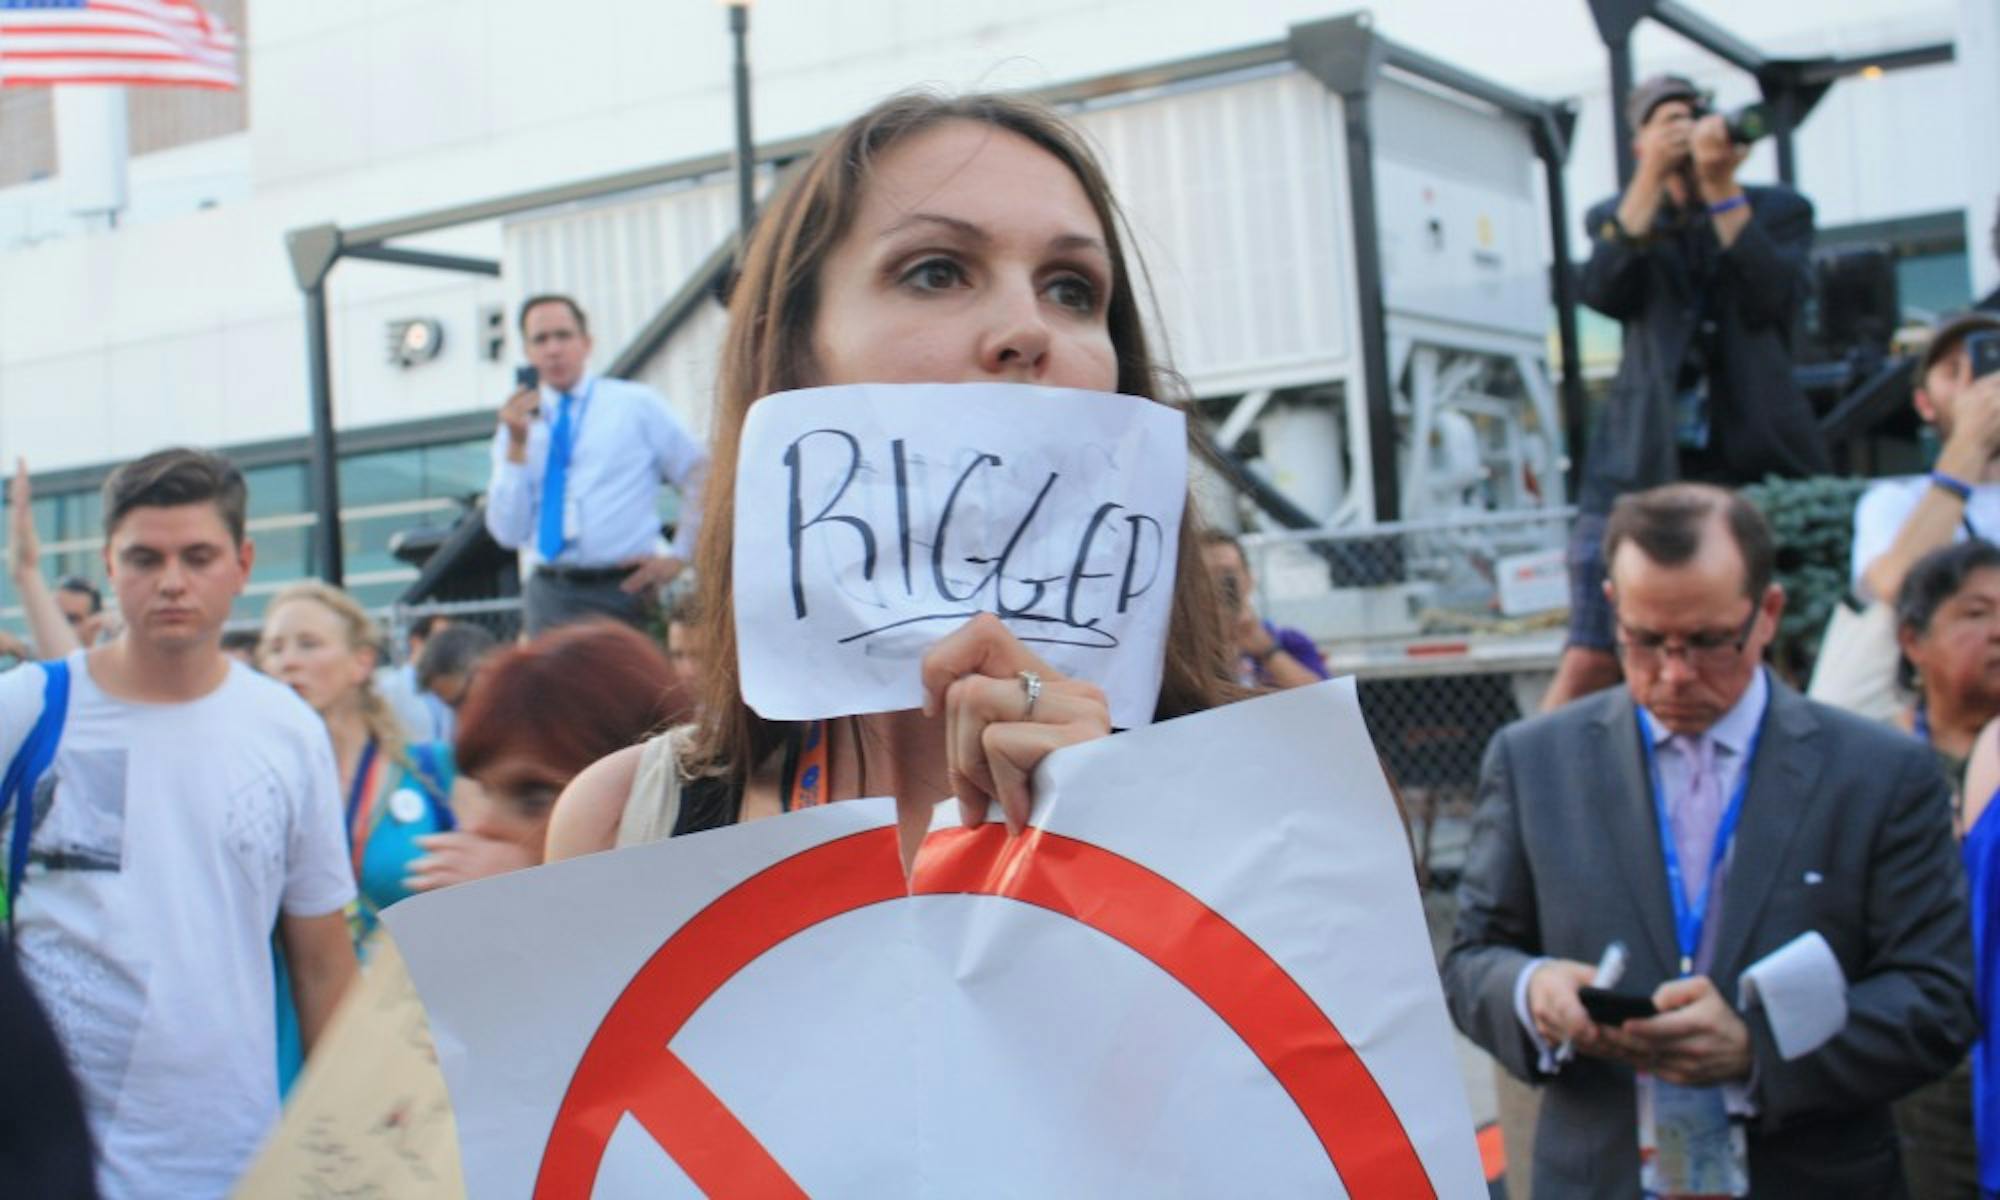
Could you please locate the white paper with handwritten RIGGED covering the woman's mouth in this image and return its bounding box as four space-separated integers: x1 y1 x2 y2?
734 384 1188 728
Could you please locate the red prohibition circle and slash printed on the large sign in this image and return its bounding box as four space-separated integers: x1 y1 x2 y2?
534 824 1436 1200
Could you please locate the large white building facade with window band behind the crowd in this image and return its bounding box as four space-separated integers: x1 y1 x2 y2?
0 0 1976 618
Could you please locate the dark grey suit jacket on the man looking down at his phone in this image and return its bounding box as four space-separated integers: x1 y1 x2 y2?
1442 682 1978 1200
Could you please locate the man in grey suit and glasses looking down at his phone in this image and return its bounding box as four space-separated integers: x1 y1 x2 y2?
1444 484 1976 1200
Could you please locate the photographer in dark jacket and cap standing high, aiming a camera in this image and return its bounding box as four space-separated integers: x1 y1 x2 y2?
1544 76 1830 708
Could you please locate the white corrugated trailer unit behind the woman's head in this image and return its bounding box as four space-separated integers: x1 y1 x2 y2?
502 16 1576 656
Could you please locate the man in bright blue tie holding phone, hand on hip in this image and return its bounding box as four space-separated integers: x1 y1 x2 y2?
486 294 708 636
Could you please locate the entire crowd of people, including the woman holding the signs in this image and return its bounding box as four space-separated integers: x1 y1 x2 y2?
0 76 2000 1196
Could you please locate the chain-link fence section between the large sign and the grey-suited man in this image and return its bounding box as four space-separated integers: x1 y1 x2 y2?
1242 508 1574 888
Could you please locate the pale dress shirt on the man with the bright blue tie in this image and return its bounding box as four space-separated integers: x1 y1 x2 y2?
486 374 708 566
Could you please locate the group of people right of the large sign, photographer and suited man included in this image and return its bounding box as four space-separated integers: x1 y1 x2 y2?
1442 76 2000 1198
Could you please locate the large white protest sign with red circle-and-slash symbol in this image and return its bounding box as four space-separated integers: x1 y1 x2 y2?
386 682 1484 1200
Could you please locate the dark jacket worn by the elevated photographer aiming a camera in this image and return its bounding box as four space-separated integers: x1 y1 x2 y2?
1580 188 1830 512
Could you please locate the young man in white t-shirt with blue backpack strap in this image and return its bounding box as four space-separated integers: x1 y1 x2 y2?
0 450 356 1200
